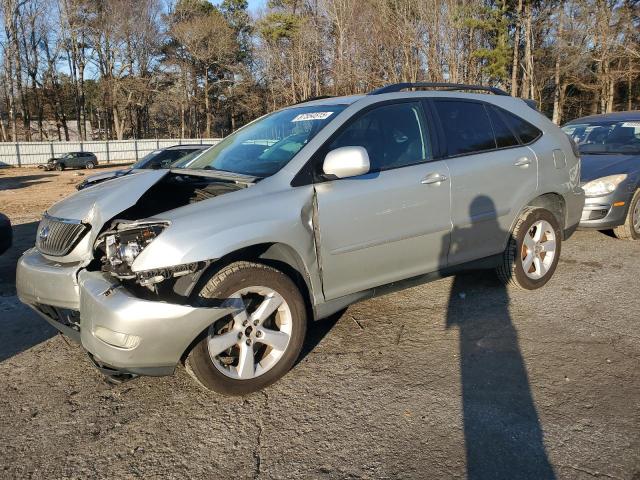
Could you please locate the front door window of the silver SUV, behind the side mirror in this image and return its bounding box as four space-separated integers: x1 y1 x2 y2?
329 102 431 171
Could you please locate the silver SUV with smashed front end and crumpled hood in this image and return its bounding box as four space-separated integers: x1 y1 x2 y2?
17 84 584 394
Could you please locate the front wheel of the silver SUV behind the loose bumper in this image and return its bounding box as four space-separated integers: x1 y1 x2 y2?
186 262 307 395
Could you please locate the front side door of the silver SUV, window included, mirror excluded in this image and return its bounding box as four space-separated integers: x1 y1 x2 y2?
315 101 451 299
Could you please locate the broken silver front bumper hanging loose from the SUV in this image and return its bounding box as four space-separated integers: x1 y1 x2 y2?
16 249 233 376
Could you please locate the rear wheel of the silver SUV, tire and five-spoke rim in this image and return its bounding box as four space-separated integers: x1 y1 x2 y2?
496 207 562 290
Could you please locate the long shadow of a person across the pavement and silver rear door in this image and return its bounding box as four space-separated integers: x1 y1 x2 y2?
443 196 555 480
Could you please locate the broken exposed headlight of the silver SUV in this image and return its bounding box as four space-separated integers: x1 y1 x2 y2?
96 222 168 278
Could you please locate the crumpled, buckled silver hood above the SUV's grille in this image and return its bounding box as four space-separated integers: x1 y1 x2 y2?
47 170 169 241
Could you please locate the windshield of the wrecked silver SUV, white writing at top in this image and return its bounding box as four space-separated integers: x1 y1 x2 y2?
189 105 346 177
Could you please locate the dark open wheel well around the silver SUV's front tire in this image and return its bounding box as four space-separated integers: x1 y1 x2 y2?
180 243 314 363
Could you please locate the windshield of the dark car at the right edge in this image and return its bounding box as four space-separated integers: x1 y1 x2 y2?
562 121 640 155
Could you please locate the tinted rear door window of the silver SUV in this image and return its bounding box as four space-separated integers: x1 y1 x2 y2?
434 100 496 155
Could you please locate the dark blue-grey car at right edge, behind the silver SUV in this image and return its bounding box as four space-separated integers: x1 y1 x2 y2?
562 111 640 240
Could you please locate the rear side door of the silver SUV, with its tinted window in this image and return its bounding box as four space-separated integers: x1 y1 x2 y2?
429 98 538 265
